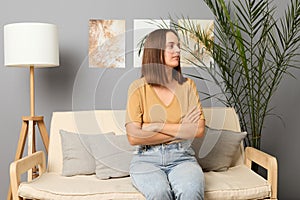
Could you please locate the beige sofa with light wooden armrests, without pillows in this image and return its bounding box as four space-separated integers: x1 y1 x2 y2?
10 108 277 200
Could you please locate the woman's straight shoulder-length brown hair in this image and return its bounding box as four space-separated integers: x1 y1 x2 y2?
142 29 186 85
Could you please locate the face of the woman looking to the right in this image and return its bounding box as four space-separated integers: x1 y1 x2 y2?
164 32 180 67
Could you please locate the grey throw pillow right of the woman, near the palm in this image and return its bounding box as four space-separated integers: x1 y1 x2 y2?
192 127 247 172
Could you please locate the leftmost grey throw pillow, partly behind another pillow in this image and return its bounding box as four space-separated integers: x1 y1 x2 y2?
60 130 114 176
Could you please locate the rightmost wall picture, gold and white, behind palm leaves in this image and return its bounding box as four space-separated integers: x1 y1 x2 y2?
178 19 214 67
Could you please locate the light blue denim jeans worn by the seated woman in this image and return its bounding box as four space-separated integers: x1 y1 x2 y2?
130 142 204 200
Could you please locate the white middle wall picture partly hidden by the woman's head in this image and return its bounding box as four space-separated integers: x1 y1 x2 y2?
133 19 171 67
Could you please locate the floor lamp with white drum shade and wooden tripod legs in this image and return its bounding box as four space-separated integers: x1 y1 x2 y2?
4 23 59 200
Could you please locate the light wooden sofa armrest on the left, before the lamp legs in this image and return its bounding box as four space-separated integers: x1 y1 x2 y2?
10 151 46 200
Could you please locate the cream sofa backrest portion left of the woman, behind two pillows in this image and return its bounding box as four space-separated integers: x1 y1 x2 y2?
48 110 126 173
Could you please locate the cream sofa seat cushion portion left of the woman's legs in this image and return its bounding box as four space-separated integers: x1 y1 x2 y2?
18 173 145 200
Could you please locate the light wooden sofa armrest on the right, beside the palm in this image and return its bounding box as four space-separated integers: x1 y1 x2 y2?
245 147 278 199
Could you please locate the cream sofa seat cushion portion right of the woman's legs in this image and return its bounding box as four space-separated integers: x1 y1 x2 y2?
205 165 271 200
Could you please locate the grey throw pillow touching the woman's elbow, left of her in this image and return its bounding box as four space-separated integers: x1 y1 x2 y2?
89 135 135 179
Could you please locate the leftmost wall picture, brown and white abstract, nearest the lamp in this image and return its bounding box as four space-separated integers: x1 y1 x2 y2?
89 19 125 68
